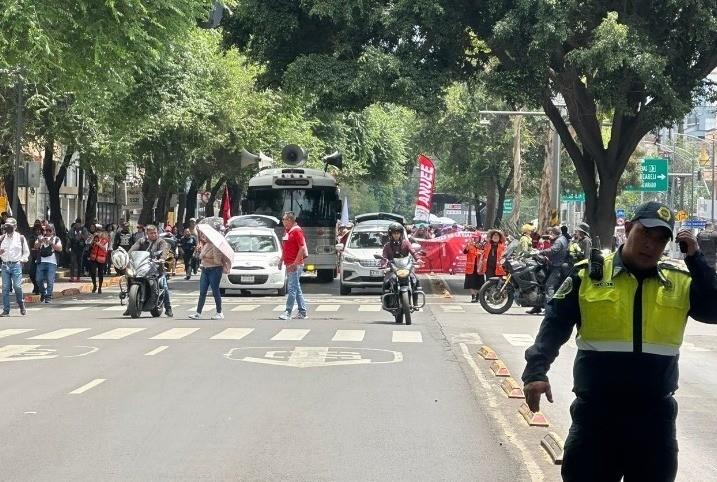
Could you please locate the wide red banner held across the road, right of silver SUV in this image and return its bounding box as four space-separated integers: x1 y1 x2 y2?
416 231 481 274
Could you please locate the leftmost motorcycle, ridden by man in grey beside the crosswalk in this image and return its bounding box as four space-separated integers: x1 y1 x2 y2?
112 248 165 318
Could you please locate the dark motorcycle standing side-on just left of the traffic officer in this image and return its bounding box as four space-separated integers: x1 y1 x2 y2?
478 241 550 315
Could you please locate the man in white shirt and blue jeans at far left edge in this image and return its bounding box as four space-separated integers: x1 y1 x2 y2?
0 218 30 316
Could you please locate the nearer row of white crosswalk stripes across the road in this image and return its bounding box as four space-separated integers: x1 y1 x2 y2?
0 327 423 344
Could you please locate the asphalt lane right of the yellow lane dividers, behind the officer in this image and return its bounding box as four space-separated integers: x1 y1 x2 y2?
442 275 717 482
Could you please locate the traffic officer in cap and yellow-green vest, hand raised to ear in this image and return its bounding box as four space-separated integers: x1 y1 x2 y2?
523 202 717 482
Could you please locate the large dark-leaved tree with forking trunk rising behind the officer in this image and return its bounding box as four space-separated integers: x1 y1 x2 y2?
228 0 717 241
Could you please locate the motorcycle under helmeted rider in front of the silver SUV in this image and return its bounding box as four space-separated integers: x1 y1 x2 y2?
374 254 426 325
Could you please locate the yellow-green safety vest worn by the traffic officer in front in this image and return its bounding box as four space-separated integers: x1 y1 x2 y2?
576 253 692 356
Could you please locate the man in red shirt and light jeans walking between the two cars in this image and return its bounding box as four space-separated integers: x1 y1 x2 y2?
279 211 309 320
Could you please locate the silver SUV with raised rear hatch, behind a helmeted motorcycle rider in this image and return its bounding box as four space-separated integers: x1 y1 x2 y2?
336 213 406 295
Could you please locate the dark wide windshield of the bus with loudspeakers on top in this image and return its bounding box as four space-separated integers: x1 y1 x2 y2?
247 187 339 227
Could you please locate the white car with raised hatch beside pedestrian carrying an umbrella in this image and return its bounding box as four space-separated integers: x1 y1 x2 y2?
219 227 286 296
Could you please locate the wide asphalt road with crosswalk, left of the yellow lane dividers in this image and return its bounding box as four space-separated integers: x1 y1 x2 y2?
0 274 548 481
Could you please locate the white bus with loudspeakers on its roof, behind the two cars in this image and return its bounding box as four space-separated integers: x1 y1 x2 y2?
242 167 341 281
